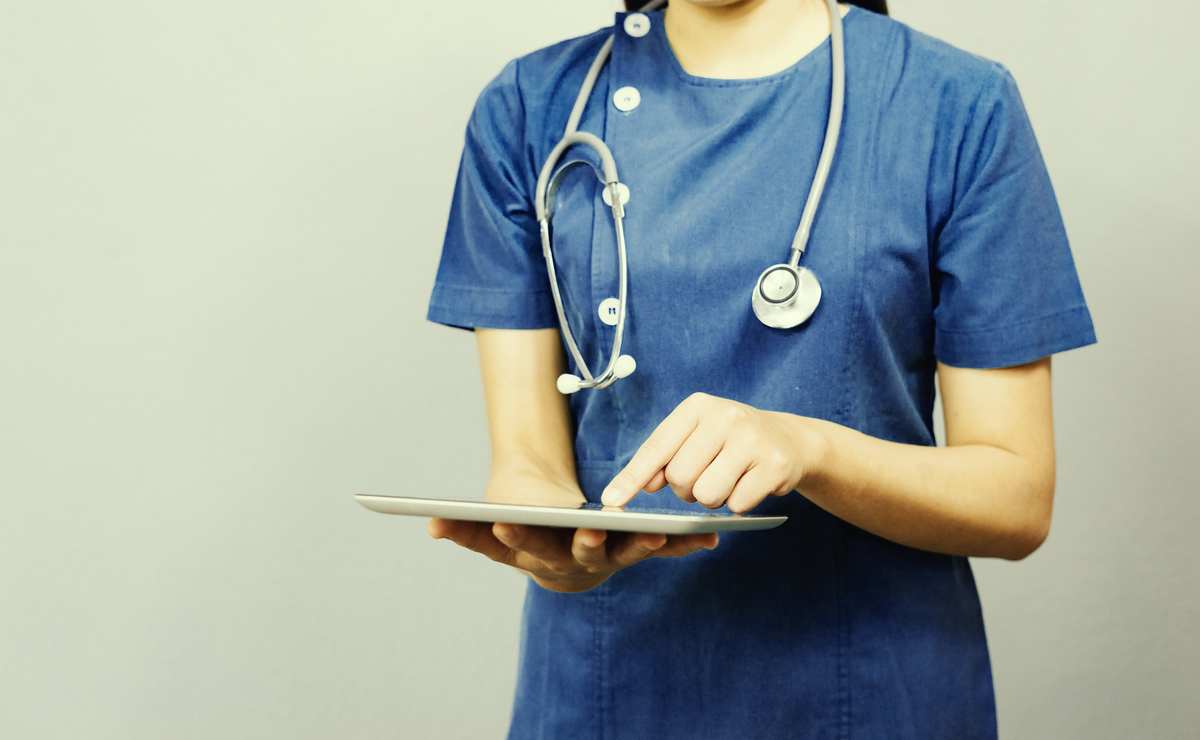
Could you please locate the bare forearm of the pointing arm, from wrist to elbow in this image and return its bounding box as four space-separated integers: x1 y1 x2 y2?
792 417 1054 559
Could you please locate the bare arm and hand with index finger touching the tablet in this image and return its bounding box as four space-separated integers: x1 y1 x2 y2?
604 357 1055 560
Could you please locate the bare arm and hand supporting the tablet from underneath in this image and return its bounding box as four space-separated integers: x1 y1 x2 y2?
428 329 718 592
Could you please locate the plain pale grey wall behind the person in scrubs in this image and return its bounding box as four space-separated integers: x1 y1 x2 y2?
0 0 1200 739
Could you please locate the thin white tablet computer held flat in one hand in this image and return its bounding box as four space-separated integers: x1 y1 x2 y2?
354 494 787 535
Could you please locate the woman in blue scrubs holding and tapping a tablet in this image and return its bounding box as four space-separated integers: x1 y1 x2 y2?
430 0 1094 740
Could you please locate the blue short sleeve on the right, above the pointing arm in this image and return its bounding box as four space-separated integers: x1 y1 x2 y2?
932 65 1096 368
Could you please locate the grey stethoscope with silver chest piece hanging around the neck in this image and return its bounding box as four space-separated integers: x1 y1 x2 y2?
534 0 846 393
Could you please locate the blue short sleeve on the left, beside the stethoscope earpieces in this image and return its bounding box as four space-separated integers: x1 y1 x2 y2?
427 62 558 329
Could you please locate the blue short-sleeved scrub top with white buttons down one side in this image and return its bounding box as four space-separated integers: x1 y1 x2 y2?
428 10 1094 740
